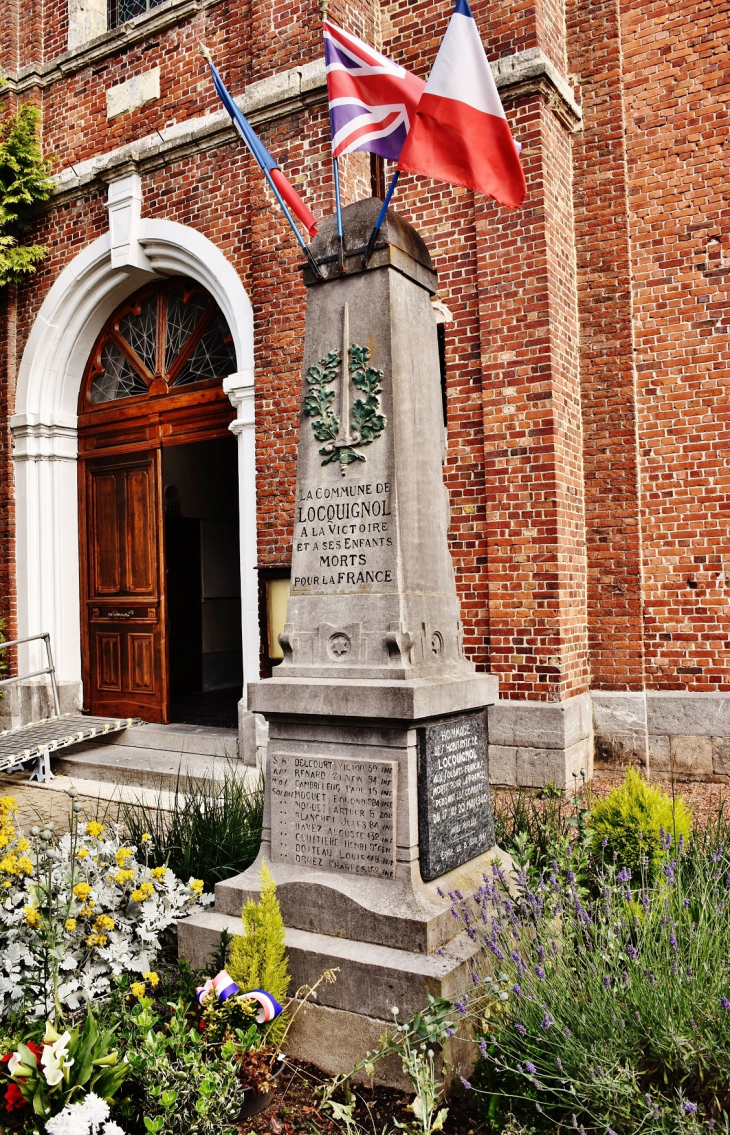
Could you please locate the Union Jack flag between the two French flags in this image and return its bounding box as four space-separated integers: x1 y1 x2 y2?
325 19 426 161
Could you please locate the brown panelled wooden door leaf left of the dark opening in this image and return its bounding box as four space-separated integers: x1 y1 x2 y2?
81 448 168 722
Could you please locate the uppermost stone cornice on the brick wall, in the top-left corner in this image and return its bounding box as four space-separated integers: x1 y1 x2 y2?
5 0 220 94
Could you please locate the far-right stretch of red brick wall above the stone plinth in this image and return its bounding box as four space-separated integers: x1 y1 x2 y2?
621 0 730 690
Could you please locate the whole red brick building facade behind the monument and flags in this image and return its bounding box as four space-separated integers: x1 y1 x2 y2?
0 0 730 783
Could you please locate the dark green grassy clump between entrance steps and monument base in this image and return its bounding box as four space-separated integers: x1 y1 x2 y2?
123 762 263 891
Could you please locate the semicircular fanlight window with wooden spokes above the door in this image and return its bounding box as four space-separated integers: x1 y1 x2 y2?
87 280 236 403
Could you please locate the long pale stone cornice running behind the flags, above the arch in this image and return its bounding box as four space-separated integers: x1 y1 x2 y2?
42 44 582 205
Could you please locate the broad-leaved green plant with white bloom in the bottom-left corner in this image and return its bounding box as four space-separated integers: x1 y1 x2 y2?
10 1008 128 1116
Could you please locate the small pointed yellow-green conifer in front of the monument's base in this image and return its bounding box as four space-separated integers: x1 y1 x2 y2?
228 864 291 1024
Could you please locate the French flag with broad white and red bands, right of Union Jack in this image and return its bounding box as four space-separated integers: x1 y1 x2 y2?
397 0 527 208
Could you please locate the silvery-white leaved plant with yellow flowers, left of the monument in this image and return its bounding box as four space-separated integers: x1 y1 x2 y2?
0 821 213 1018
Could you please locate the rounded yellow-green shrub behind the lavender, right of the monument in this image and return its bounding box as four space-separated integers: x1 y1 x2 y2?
589 768 691 878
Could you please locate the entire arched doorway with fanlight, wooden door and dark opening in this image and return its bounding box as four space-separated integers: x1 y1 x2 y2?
78 277 243 724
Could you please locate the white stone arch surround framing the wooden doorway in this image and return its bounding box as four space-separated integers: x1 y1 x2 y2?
10 212 259 715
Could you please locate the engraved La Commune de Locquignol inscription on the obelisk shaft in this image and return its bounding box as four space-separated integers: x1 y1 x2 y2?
292 480 396 591
